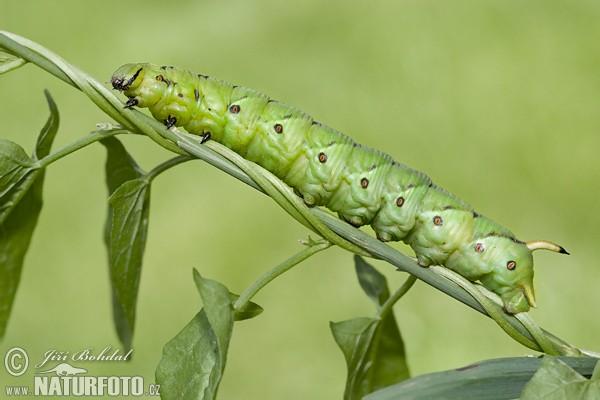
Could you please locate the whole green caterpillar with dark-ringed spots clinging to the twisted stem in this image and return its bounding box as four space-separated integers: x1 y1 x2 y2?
111 63 569 314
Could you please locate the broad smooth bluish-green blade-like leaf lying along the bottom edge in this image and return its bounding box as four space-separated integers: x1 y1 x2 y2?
365 357 596 400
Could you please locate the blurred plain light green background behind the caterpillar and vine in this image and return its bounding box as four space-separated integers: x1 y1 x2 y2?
0 0 600 399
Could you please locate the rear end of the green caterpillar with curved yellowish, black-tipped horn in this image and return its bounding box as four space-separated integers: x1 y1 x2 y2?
480 237 569 314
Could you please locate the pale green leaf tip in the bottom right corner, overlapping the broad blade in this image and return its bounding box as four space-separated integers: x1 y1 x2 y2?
521 357 600 400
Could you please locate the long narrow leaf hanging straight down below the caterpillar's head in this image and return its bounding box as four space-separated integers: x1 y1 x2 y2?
101 137 150 349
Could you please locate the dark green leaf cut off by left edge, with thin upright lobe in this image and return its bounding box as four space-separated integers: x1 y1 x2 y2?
0 92 59 337
